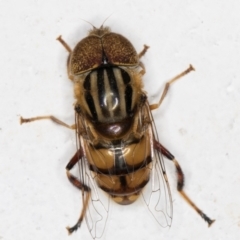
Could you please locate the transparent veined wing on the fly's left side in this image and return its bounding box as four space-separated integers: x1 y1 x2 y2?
76 115 110 239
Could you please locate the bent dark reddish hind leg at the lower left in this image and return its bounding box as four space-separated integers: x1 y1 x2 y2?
66 148 91 234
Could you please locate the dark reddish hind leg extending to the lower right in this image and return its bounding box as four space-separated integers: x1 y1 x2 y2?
154 140 215 227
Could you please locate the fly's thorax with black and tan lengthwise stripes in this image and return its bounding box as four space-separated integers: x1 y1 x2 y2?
75 66 140 139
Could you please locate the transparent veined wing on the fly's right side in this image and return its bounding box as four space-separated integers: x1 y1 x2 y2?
142 103 173 227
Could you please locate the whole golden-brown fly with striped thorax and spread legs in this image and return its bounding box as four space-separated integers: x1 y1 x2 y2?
21 25 214 239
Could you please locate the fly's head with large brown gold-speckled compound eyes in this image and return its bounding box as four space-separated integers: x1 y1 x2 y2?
69 28 139 75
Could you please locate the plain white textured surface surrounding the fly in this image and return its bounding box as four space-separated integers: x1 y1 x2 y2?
0 0 240 240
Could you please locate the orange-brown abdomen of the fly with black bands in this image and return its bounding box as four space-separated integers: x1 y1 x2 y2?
86 132 152 204
